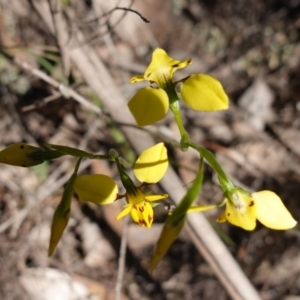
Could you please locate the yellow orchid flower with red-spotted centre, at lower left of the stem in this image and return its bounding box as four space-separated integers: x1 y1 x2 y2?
75 143 168 228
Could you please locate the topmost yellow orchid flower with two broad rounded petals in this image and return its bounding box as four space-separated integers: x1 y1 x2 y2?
128 48 228 126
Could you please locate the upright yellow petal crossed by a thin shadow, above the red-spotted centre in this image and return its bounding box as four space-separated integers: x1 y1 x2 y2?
133 143 169 183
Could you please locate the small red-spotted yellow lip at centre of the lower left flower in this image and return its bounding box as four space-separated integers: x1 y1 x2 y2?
131 201 153 228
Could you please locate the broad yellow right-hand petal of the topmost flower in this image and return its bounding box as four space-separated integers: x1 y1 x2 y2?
180 74 229 111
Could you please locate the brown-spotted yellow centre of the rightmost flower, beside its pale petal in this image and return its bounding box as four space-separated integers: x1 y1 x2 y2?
223 192 257 230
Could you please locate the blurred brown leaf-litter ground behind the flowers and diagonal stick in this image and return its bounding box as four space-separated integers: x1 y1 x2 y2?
0 0 300 300
